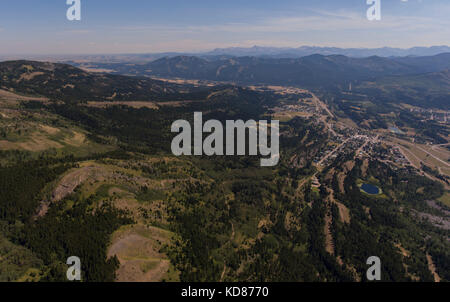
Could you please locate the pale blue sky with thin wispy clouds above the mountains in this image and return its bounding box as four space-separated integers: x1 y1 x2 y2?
0 0 450 55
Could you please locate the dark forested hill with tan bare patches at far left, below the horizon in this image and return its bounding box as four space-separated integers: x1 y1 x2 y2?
0 61 204 101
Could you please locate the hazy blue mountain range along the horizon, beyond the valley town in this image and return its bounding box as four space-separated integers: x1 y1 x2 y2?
63 53 450 109
